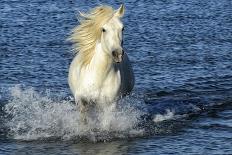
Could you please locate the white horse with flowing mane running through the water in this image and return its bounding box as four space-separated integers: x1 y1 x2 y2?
68 5 134 122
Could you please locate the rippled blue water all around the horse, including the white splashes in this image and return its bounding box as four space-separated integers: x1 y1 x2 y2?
0 0 232 155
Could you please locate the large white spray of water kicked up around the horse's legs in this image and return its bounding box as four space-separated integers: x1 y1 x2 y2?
4 86 144 141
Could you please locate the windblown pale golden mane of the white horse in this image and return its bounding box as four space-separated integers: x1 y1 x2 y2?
69 6 114 65
